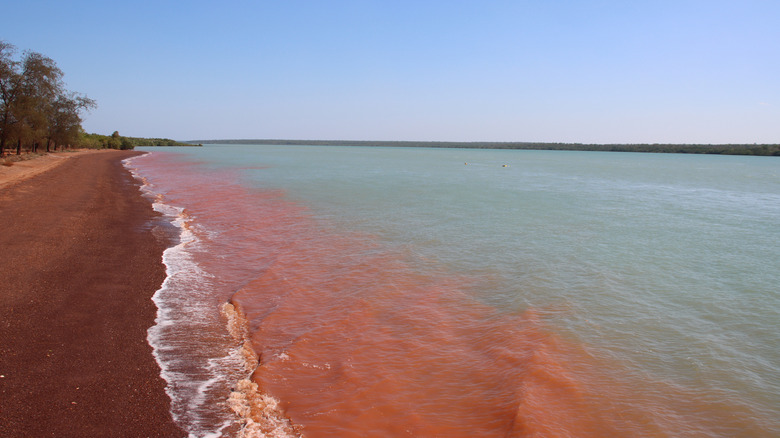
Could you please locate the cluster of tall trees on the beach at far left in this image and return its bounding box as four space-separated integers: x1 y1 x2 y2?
0 41 96 156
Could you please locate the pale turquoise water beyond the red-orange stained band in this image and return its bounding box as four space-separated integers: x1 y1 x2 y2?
136 145 780 436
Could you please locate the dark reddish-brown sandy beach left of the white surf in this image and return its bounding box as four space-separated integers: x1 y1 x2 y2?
0 151 185 437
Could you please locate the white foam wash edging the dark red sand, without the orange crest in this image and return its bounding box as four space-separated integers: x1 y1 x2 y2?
124 159 237 437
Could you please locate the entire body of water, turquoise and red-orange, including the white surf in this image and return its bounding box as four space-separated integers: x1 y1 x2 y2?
127 145 780 437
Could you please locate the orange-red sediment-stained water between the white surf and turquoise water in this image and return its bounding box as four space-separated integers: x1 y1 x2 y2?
129 153 608 436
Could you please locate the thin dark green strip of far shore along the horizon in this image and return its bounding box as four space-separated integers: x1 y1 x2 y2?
185 139 780 156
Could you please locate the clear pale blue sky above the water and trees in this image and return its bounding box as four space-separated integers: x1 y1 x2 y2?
0 0 780 143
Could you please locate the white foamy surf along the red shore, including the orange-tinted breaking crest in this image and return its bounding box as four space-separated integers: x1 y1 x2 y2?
123 158 295 438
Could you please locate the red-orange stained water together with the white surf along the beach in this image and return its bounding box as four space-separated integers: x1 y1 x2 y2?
128 154 772 437
